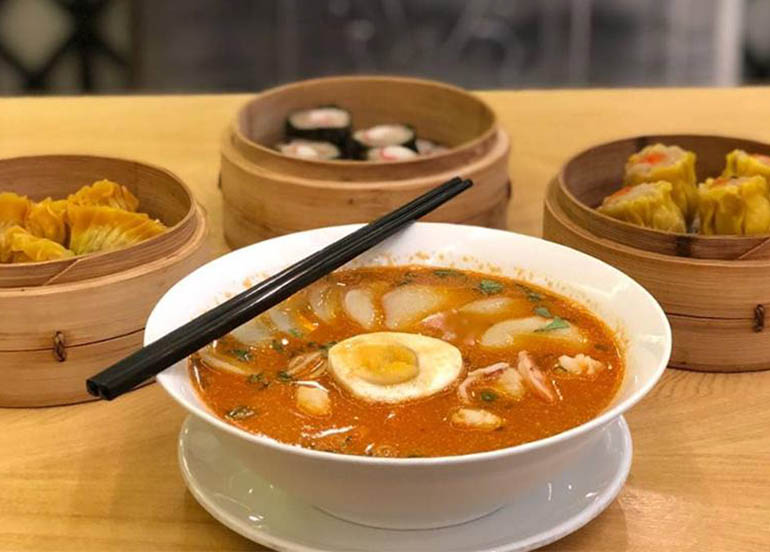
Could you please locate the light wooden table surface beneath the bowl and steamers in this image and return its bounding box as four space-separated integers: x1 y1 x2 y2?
0 89 770 551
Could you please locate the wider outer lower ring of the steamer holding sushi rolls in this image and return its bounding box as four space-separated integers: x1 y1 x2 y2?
221 128 510 248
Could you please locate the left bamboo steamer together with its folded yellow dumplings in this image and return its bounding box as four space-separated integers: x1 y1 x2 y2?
0 155 207 406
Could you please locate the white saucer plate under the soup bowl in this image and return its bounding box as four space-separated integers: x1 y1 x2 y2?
179 416 632 552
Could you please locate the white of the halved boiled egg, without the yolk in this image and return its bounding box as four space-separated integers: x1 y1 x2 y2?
329 332 463 404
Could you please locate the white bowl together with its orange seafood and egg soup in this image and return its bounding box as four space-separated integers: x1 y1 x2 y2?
145 223 671 529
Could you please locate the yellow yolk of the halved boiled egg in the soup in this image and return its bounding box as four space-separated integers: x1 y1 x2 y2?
351 343 420 385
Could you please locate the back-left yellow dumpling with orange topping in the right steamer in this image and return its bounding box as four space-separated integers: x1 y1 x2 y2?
623 144 698 224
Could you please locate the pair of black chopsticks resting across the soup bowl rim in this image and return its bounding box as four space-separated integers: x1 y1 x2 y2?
86 177 473 400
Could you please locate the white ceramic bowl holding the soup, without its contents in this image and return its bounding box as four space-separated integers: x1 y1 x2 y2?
145 223 671 529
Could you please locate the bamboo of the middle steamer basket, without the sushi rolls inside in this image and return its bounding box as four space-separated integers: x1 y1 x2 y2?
220 77 511 247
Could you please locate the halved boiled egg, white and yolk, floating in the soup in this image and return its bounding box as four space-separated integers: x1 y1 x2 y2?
329 332 463 403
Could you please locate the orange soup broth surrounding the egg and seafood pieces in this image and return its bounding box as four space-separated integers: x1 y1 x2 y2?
190 267 623 457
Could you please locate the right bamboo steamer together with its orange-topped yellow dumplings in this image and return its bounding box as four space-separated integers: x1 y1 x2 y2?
543 135 770 371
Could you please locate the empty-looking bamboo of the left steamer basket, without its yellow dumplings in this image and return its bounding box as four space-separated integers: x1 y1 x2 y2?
0 155 207 406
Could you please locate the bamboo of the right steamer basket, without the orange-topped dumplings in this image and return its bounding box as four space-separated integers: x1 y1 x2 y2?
543 135 770 372
